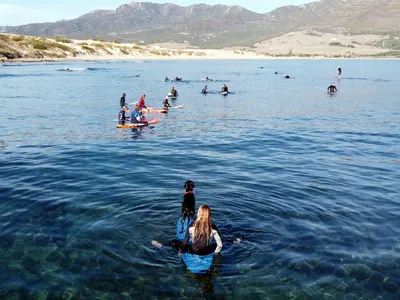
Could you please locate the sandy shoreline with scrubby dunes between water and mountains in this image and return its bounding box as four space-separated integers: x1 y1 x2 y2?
0 34 400 63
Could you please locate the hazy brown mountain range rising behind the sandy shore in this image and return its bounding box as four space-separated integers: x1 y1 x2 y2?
0 0 400 48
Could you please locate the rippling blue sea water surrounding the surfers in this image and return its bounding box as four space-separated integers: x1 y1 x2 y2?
0 60 400 299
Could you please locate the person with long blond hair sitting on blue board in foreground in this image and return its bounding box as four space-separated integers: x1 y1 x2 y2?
180 205 222 255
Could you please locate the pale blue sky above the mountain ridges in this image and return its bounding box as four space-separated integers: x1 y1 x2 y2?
0 0 312 25
